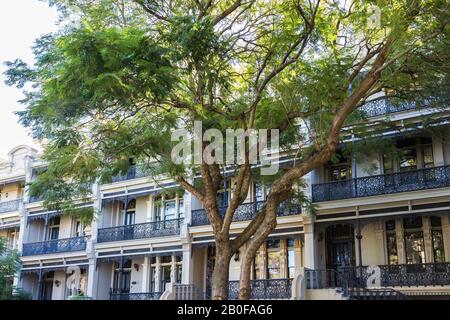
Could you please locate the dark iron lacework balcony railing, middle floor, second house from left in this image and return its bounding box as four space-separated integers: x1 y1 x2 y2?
97 218 183 243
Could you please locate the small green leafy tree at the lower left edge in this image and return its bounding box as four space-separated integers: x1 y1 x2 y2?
0 237 21 300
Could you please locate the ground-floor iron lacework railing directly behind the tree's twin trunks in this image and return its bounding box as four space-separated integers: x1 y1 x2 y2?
228 279 292 300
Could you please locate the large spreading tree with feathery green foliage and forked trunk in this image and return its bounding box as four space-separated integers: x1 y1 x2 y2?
6 0 449 299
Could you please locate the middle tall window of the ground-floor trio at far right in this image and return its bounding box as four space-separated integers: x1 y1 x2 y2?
403 217 425 264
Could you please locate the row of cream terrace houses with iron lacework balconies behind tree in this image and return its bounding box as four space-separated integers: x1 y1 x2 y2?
0 100 450 300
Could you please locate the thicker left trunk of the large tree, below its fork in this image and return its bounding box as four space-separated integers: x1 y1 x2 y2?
212 240 231 300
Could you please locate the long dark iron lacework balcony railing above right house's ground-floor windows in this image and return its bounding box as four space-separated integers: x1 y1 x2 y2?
312 166 450 202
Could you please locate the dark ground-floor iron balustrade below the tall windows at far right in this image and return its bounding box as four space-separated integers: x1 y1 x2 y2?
339 262 450 287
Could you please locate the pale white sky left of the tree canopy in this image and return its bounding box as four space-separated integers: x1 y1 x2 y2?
0 0 58 160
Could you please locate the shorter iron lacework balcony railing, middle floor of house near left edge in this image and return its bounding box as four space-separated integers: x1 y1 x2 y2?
22 237 87 256
